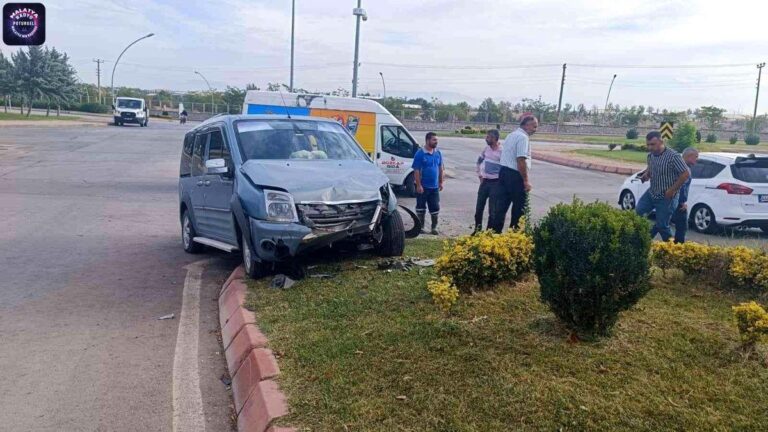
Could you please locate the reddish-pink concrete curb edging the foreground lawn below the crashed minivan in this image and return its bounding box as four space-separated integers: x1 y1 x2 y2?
218 266 296 432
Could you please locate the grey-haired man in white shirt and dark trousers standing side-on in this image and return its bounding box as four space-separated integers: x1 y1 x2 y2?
491 115 539 233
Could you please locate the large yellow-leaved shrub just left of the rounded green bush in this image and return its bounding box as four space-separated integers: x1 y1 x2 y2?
435 231 533 291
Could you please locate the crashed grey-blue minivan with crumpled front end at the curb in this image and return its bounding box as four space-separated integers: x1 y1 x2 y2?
179 115 405 277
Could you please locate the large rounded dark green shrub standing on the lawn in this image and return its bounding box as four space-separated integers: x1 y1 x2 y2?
533 199 651 335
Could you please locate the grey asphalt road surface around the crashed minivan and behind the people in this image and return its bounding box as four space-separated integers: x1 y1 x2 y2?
0 121 765 431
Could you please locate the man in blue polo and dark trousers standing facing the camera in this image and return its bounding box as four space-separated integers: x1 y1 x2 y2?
411 132 443 235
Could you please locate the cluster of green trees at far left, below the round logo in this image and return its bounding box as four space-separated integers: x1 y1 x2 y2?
0 46 79 116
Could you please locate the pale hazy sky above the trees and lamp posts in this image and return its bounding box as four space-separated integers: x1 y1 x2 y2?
10 0 768 113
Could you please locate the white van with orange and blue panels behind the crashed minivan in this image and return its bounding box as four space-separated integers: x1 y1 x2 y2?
243 90 419 196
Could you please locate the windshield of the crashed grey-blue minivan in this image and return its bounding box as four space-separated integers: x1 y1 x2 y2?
235 119 366 160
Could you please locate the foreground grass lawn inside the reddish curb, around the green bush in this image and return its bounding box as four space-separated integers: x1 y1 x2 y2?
248 240 768 431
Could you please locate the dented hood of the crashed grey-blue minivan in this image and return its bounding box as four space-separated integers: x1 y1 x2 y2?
240 159 388 203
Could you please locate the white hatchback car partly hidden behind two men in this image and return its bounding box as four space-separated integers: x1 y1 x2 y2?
619 153 768 233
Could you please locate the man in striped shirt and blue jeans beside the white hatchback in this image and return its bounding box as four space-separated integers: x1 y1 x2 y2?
635 131 691 241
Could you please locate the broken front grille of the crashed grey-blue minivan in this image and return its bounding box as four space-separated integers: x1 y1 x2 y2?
296 201 379 230
